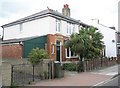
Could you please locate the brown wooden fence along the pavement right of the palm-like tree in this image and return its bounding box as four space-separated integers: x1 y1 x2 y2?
83 58 118 71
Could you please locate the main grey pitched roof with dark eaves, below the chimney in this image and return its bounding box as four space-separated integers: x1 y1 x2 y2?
1 9 89 28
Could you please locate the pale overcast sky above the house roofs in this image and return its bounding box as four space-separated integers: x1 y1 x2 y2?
0 0 119 36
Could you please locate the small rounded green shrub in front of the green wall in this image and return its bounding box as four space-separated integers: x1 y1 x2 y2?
28 48 49 65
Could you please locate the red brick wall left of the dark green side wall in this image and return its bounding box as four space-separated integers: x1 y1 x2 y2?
2 44 23 58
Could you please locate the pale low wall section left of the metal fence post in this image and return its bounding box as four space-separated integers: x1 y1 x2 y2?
1 62 11 86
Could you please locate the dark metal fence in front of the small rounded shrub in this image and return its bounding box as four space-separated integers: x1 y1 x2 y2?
11 62 53 85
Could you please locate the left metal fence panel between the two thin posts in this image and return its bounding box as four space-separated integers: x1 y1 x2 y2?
12 64 33 85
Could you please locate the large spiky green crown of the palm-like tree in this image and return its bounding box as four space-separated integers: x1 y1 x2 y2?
65 27 104 61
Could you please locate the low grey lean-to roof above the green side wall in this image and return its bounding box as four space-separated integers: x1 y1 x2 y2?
0 36 40 44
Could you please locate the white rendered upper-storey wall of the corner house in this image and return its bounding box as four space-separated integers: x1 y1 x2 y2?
3 16 78 40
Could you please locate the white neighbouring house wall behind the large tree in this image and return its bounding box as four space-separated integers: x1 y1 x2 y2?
91 19 117 58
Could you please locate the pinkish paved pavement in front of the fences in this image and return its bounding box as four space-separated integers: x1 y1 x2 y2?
30 65 118 86
